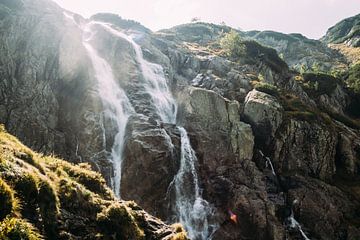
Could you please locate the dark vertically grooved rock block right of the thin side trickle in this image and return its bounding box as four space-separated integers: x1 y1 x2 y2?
274 119 337 179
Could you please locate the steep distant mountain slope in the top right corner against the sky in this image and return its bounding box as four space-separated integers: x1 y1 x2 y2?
321 14 360 47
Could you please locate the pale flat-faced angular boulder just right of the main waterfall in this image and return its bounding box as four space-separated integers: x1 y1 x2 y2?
182 87 254 160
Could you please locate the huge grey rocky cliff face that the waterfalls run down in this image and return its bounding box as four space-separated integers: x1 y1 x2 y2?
0 0 360 240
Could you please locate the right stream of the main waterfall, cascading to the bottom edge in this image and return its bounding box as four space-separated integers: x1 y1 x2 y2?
98 23 217 240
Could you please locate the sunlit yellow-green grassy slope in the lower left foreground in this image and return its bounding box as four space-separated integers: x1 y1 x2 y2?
0 125 187 240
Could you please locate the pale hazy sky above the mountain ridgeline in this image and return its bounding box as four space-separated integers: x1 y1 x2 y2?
54 0 360 39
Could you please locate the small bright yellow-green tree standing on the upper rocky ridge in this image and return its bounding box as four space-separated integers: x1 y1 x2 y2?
220 30 245 58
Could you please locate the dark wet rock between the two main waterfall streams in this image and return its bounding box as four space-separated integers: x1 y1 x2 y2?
120 117 180 219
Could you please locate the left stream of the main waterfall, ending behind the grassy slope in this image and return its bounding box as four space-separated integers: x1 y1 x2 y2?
83 23 134 197
